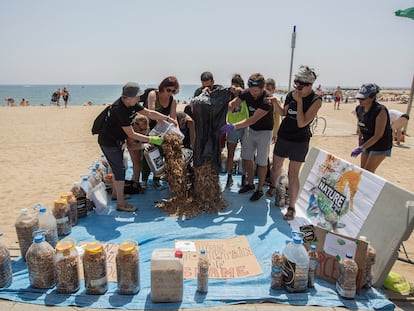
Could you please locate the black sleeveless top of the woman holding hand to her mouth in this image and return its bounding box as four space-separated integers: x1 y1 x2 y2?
277 91 321 142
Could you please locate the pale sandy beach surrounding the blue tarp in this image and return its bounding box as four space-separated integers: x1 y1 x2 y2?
0 94 414 288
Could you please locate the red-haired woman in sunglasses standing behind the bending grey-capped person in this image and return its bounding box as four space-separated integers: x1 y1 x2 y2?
142 76 180 190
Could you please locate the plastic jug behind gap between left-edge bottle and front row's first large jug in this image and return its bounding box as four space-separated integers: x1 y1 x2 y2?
14 208 39 260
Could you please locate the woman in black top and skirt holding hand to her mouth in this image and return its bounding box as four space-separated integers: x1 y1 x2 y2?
266 66 322 220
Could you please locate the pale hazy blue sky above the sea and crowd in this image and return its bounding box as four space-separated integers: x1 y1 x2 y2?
0 0 414 87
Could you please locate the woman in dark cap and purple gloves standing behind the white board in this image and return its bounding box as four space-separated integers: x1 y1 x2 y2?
351 83 392 173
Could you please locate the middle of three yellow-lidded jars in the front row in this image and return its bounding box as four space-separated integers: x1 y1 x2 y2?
82 242 108 295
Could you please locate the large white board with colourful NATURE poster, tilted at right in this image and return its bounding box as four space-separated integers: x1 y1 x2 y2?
291 148 414 286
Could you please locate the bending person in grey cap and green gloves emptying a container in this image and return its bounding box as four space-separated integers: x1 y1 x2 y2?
98 82 176 212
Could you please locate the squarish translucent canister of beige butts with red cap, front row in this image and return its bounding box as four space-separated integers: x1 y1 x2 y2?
151 248 184 302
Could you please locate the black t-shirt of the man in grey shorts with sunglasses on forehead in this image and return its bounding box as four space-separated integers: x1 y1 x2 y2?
239 89 274 131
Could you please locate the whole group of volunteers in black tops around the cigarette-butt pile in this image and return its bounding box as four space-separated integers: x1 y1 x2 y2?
94 66 402 220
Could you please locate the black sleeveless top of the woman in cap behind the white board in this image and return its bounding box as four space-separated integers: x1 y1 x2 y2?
356 102 392 151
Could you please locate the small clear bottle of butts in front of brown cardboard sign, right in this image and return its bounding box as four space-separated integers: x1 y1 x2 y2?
336 253 358 299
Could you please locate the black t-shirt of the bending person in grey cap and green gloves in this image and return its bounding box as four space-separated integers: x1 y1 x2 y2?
98 98 144 147
